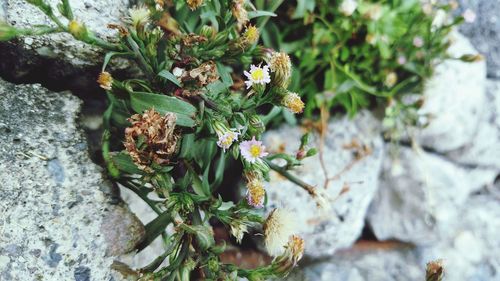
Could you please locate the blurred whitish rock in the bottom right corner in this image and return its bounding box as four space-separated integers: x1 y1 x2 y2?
421 194 500 281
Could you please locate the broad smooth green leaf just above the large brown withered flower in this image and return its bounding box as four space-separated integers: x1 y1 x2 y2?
130 92 196 127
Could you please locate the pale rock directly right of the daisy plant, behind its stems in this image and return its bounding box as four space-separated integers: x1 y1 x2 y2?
264 112 384 257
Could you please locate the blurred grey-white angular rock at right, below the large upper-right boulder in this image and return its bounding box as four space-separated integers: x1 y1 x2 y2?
368 147 497 245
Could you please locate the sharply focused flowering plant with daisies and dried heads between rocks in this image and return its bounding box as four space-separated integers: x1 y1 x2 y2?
0 0 317 280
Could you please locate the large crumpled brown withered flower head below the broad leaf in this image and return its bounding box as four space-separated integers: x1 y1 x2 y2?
124 109 180 172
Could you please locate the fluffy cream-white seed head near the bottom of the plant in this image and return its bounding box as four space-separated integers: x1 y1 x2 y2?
264 209 295 257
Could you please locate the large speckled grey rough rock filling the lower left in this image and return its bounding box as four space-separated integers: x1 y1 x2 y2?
0 80 141 280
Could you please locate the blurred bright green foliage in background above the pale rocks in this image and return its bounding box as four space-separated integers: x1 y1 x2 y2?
262 0 463 117
